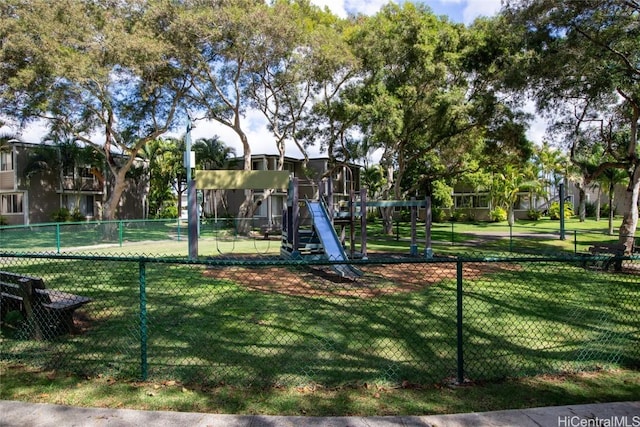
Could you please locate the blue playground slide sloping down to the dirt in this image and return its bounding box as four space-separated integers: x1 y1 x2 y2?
307 200 362 279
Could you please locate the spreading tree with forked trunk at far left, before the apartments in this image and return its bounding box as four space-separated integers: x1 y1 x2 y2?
0 0 186 219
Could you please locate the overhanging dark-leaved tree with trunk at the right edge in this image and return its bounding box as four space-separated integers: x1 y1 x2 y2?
505 0 640 249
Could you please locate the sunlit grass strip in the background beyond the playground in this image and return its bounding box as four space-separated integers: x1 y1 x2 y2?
0 218 632 256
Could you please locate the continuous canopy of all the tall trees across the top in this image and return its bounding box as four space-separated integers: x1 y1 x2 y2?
0 0 640 247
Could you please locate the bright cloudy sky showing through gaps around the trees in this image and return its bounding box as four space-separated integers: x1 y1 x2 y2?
5 0 544 163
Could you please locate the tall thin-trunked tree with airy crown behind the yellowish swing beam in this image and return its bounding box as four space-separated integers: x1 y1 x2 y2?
172 0 356 232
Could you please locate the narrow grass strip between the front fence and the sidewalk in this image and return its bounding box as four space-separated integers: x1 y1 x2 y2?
0 362 640 416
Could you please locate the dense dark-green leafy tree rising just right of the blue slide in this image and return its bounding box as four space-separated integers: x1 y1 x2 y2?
345 3 528 232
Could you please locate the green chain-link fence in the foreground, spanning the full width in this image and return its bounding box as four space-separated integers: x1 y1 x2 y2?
0 253 640 385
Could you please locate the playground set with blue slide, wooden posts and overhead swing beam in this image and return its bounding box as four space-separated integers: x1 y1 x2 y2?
188 170 432 279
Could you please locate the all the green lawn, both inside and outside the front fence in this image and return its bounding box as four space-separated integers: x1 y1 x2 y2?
0 217 640 415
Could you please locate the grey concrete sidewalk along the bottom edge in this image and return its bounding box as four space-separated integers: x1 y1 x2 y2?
0 400 640 427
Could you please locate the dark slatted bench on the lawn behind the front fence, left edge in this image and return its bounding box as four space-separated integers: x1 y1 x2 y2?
0 271 91 340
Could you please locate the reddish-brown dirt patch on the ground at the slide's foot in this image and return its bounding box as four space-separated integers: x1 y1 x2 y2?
203 262 520 298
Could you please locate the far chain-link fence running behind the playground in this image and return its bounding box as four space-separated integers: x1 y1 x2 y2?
0 218 640 256
